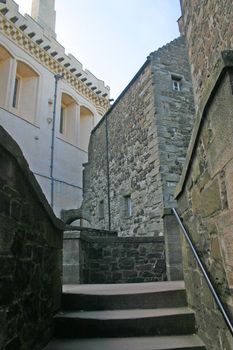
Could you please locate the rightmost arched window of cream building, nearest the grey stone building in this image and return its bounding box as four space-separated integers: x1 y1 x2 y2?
80 106 94 151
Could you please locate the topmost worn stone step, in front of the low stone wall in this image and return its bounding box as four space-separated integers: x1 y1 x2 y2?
62 281 187 310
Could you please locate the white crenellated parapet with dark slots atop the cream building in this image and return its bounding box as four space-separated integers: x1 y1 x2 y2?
0 0 110 107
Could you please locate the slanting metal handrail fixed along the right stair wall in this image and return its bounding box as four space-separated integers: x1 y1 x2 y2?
172 208 233 336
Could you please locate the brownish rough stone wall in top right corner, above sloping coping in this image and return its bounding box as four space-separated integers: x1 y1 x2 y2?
181 0 233 105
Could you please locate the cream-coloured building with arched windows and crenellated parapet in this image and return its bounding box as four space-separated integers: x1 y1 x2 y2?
0 0 109 216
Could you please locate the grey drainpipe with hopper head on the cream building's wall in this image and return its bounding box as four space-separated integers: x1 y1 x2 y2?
50 74 63 208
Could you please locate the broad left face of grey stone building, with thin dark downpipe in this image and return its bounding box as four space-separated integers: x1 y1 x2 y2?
83 59 162 236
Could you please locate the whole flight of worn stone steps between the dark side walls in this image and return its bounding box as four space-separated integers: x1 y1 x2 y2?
44 282 205 350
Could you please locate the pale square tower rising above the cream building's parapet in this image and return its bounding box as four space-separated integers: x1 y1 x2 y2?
31 0 56 36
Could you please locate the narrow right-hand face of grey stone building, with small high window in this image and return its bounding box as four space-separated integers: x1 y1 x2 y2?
151 37 195 208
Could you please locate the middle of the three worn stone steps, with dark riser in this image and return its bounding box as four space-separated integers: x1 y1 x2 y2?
55 307 195 338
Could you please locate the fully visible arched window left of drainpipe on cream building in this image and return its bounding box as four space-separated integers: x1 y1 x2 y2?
12 61 39 122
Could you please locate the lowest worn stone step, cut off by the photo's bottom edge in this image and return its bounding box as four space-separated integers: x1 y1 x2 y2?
44 335 205 350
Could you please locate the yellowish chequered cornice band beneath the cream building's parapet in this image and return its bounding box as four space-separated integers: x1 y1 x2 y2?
0 13 110 115
